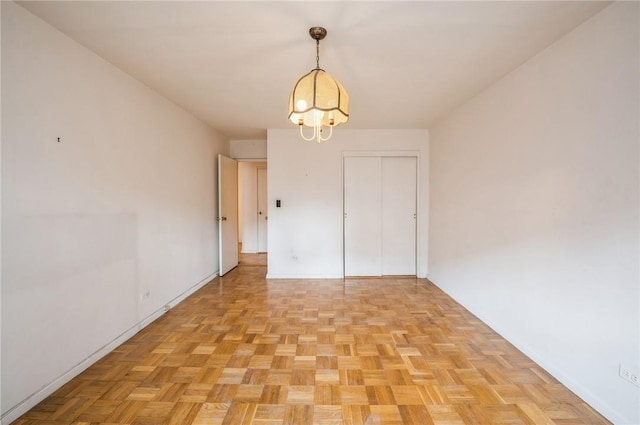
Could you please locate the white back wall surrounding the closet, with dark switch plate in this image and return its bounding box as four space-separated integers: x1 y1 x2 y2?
267 131 429 278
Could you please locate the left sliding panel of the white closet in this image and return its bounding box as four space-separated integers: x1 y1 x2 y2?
344 157 382 276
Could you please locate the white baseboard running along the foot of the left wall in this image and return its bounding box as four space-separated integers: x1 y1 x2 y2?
0 272 218 425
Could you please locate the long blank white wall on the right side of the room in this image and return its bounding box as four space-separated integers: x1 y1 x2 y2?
429 3 640 424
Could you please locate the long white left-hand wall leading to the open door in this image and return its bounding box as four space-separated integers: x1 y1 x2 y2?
2 2 228 422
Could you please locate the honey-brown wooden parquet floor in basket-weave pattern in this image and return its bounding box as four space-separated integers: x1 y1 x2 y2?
14 255 609 425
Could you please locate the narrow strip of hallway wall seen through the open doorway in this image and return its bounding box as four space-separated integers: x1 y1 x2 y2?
238 161 267 253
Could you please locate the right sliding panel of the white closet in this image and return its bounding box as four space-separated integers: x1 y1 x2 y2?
382 156 417 276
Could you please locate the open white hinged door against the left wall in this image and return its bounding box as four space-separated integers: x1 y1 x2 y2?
218 155 238 276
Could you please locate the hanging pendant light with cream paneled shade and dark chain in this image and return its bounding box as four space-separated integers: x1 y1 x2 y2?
289 27 349 143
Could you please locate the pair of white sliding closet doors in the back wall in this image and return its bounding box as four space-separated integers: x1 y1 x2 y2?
344 156 417 276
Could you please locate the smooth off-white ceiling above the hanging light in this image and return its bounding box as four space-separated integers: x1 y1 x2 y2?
19 1 610 139
